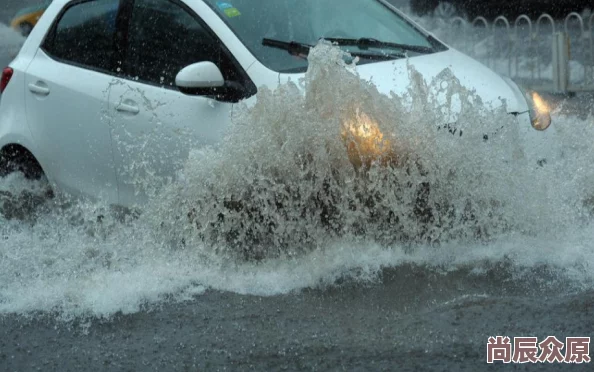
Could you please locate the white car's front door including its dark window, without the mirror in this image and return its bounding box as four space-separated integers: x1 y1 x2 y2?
110 0 255 206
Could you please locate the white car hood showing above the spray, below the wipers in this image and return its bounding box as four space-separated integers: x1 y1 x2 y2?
350 49 528 113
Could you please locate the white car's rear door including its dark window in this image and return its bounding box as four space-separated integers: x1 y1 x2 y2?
25 0 120 203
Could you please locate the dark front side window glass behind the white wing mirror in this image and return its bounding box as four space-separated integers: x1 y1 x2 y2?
124 0 234 88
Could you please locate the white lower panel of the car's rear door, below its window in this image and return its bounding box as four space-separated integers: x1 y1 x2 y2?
24 49 118 201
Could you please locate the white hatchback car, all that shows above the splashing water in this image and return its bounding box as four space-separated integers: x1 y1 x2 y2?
0 0 550 206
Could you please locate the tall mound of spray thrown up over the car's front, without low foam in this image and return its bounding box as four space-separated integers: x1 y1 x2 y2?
151 44 588 258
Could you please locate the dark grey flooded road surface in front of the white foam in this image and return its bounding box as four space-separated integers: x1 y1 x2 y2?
0 267 594 371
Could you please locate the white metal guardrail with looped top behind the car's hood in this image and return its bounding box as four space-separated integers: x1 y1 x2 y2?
439 13 594 93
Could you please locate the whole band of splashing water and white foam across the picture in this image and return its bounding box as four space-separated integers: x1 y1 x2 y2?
0 45 594 319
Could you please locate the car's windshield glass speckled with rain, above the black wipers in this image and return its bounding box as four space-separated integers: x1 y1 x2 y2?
205 0 435 72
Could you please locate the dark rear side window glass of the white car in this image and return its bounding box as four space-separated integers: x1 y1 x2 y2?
43 0 120 71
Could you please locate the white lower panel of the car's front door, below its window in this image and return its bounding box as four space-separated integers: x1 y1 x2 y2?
108 79 233 206
